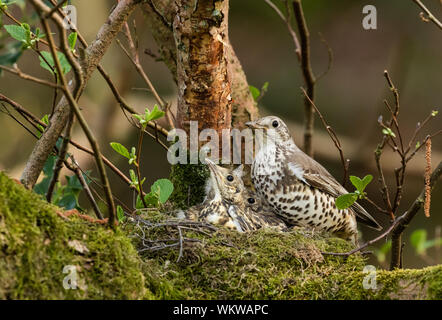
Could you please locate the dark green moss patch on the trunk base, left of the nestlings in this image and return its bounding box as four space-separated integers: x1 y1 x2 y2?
170 163 210 208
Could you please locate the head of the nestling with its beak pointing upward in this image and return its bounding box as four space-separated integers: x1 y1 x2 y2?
206 159 244 204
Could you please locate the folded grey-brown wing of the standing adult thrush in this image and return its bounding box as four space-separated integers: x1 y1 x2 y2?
287 150 382 230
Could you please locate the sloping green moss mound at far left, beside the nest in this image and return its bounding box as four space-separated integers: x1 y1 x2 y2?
0 173 150 299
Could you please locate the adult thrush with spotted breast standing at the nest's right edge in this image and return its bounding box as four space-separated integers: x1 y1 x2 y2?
248 116 380 243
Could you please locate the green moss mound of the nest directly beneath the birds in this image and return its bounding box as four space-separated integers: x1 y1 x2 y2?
140 229 364 299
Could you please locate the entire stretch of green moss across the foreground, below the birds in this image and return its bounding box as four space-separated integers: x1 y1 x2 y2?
0 173 442 299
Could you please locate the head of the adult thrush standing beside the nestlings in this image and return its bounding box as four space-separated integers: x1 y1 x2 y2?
246 116 293 144
